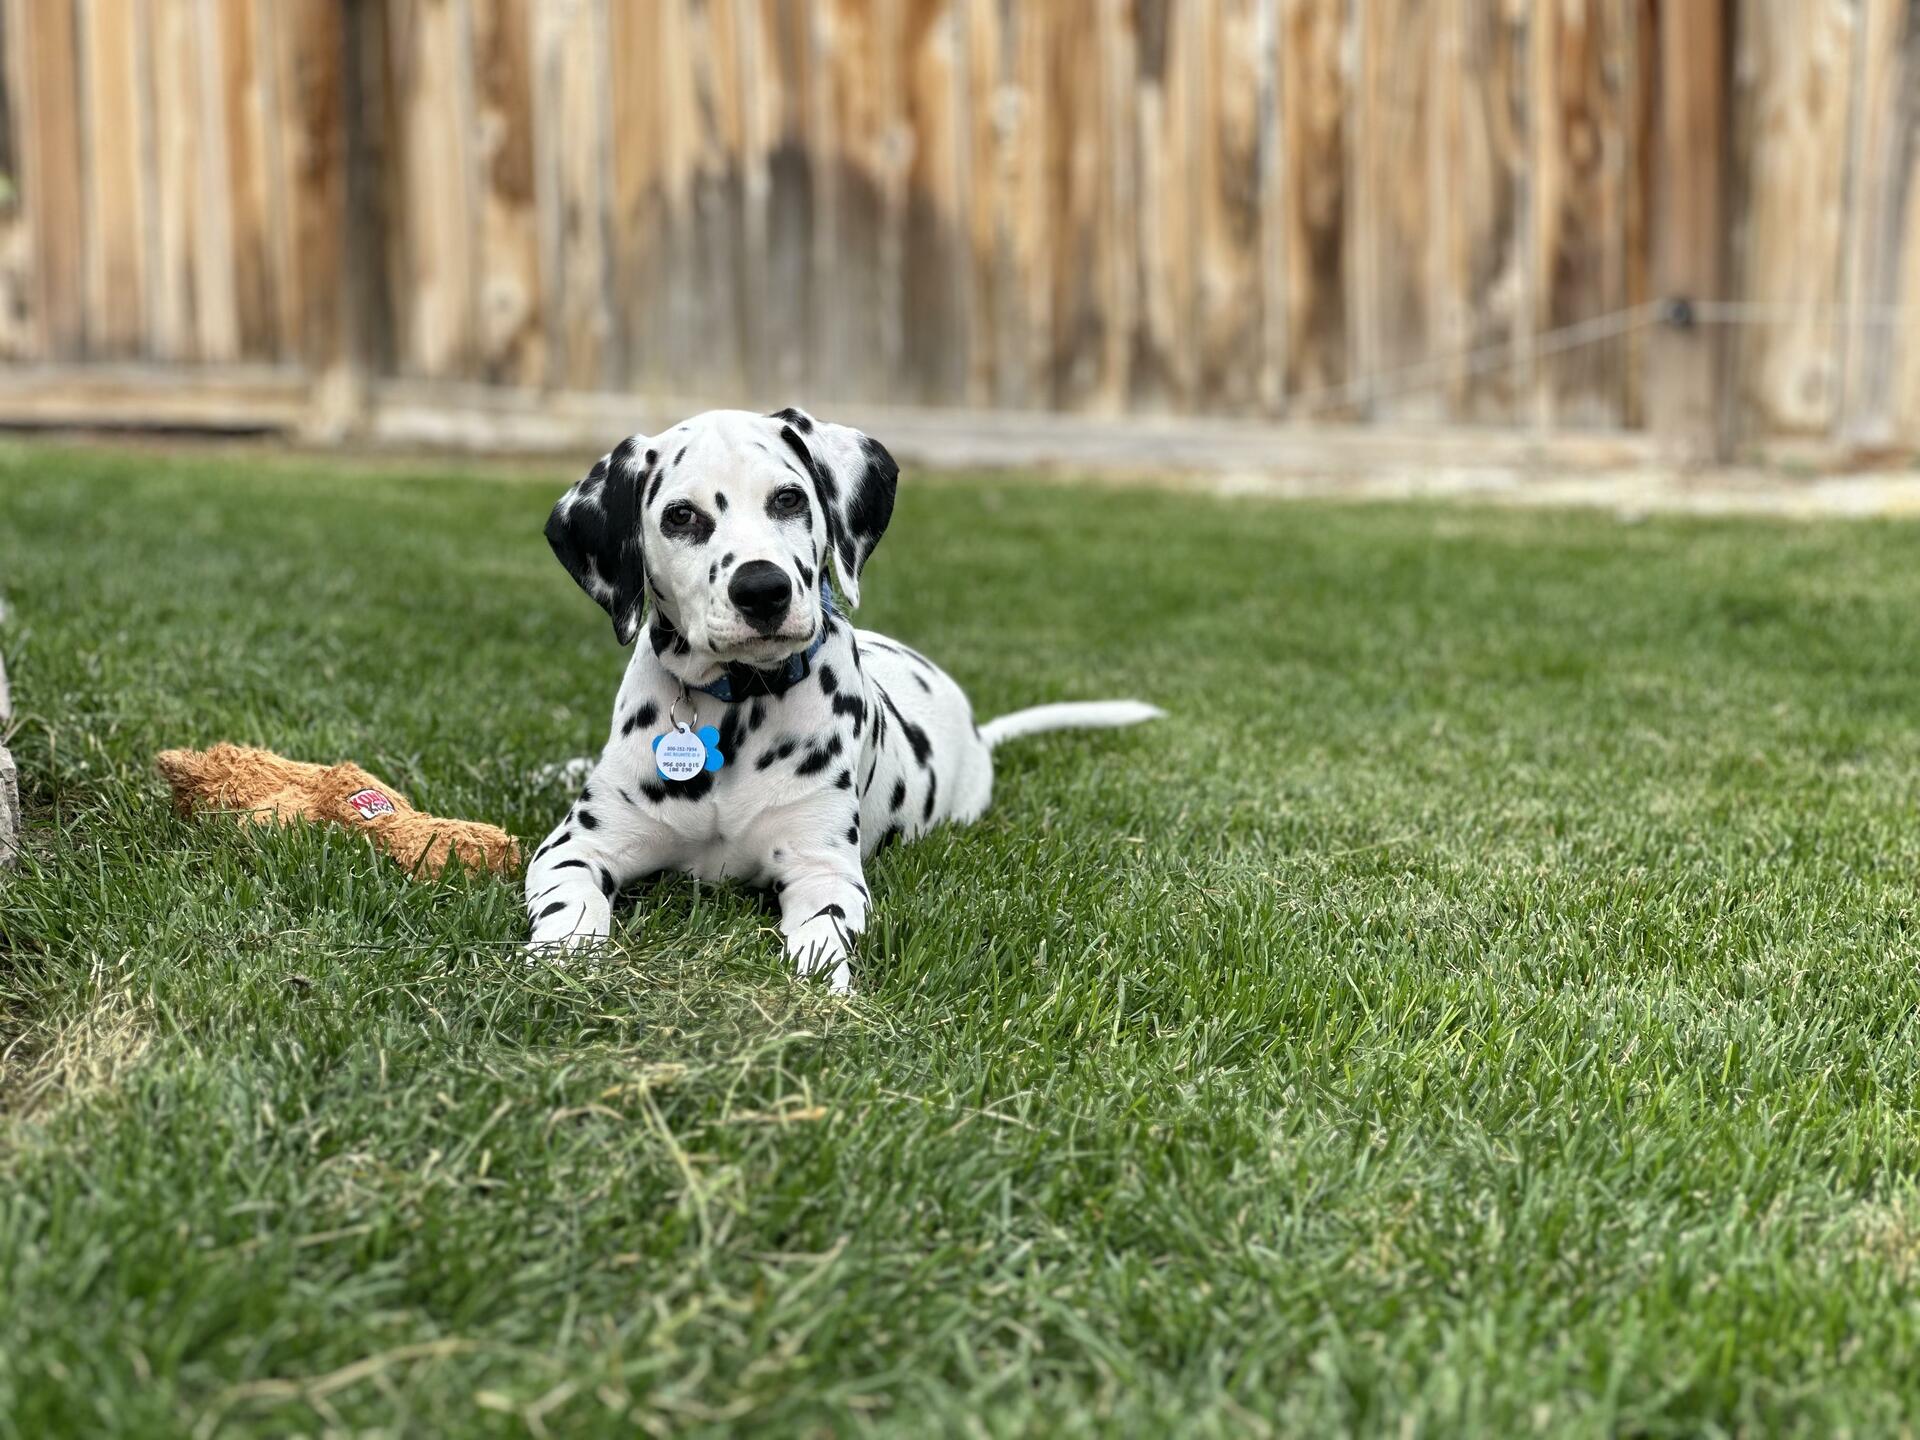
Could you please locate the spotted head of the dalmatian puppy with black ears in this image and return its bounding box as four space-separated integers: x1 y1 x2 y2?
547 409 899 666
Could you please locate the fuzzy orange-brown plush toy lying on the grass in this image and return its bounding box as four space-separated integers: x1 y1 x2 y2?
157 743 520 876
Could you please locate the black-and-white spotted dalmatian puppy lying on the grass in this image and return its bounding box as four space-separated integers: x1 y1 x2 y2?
526 409 1160 991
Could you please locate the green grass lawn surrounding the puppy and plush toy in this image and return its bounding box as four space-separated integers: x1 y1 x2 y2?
0 445 1920 1438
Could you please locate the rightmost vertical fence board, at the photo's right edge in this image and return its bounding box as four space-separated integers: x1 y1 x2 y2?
1841 0 1920 447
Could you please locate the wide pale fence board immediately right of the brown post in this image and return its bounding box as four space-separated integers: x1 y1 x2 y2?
1732 0 1857 434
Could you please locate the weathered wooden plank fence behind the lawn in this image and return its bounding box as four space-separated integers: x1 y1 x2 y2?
0 0 1920 456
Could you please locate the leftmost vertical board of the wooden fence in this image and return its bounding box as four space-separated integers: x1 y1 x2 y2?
8 0 88 359
